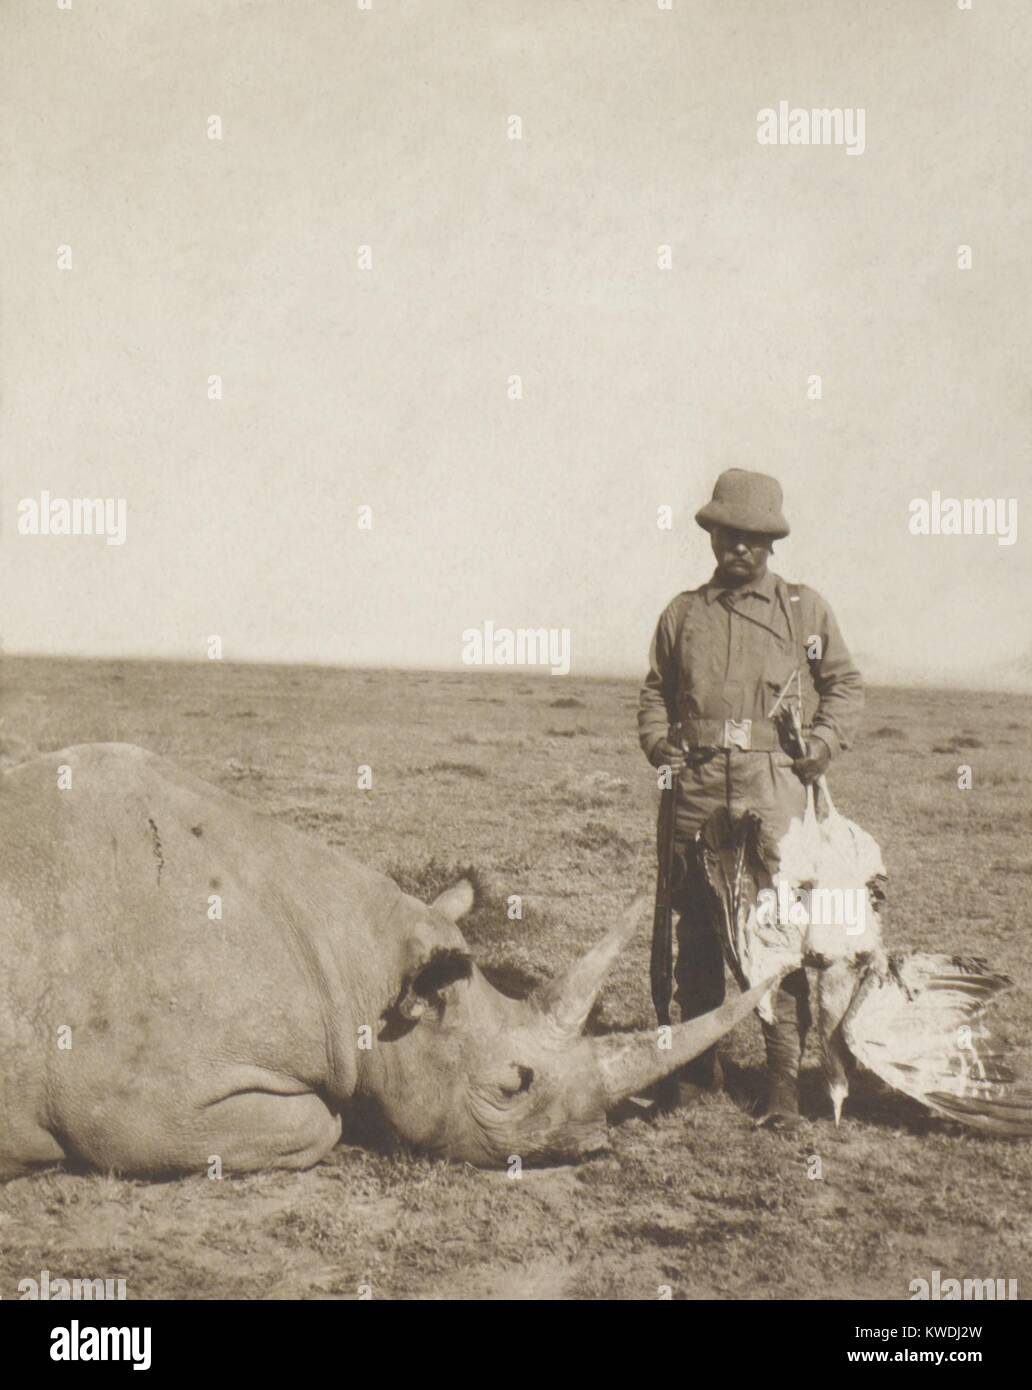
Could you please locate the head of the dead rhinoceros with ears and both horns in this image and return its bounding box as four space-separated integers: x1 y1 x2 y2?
378 880 771 1166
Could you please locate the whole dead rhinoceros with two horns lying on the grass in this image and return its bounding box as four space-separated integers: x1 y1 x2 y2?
0 744 771 1177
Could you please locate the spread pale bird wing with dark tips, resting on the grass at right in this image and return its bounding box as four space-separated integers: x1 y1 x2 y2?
843 955 1032 1137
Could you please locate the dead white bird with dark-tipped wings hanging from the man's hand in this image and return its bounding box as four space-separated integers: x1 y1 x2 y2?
697 781 1032 1136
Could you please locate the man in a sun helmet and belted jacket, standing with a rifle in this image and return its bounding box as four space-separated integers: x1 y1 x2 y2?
638 468 864 1131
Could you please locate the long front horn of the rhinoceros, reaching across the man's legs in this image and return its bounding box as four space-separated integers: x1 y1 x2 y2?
591 972 784 1105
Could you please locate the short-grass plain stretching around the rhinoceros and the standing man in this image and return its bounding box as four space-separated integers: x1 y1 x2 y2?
0 659 1032 1300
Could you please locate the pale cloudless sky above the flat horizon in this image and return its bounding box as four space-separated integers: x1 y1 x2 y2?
0 0 1032 676
